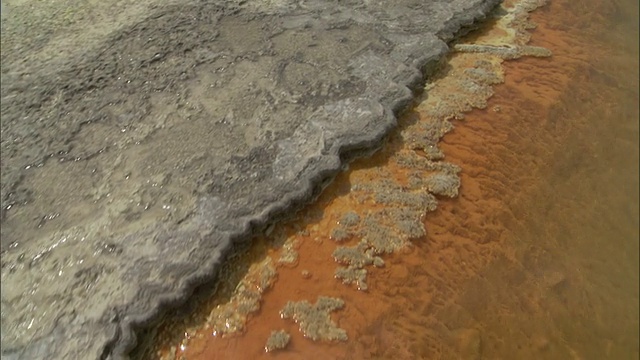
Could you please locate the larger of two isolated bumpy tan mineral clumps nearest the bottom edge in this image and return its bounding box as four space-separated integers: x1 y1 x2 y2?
280 296 347 341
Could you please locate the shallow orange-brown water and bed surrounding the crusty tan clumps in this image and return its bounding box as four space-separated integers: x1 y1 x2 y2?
148 0 640 359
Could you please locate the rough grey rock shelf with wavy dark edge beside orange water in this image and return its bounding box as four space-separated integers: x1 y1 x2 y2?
0 0 499 359
